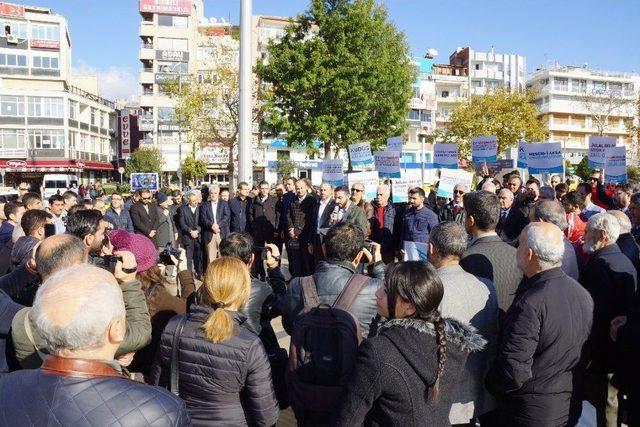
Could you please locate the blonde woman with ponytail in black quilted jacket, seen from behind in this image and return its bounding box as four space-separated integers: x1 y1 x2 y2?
151 257 279 426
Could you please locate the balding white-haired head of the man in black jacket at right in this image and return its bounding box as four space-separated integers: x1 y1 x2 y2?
516 222 564 277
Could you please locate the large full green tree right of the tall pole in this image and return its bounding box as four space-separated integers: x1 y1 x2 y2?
256 0 416 164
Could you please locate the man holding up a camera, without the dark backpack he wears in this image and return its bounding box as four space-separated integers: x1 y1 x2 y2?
282 223 387 338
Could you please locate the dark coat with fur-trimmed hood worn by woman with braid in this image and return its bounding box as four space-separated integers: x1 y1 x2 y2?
335 318 485 427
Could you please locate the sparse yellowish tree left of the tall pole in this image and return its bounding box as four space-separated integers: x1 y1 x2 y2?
163 36 261 190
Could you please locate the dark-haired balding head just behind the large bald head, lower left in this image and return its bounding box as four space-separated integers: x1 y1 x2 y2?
35 234 87 280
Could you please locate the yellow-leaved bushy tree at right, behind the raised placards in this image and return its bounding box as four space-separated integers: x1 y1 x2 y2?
430 90 547 157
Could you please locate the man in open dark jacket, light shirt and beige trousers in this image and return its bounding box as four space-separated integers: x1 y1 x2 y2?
200 185 230 264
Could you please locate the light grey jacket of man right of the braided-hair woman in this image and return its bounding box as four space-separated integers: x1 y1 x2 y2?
437 264 498 424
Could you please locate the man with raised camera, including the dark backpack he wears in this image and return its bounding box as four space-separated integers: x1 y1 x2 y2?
282 223 386 426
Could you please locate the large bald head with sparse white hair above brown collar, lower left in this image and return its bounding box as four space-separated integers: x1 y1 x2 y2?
31 264 125 354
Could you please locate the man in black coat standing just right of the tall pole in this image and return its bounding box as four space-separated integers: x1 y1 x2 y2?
248 181 278 280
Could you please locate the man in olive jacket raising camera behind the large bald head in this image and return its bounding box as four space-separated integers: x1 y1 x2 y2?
11 234 151 369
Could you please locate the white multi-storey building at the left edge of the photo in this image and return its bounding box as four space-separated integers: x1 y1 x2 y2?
0 3 116 190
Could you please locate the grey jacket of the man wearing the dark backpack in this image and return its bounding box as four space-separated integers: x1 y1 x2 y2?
282 261 387 338
